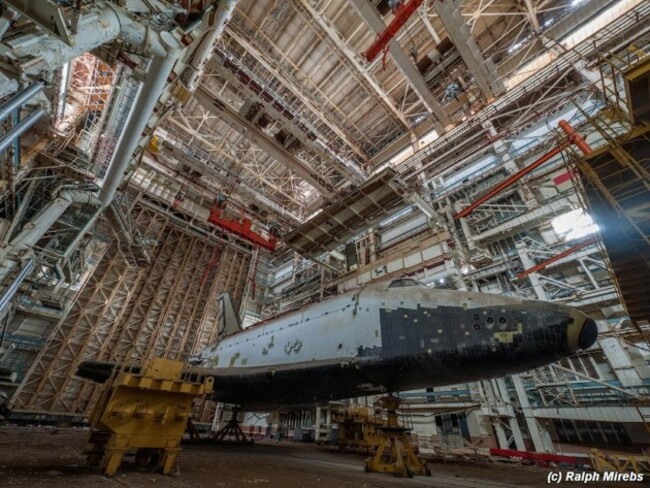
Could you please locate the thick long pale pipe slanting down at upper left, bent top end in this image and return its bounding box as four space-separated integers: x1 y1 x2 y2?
99 32 182 207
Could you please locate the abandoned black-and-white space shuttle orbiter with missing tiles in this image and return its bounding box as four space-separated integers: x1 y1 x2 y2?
77 278 598 410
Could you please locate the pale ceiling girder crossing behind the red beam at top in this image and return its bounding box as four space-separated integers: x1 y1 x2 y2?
350 0 449 129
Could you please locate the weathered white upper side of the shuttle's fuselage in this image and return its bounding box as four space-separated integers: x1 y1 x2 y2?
201 283 540 368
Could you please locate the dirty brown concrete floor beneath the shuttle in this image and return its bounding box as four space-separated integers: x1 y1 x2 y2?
0 426 620 488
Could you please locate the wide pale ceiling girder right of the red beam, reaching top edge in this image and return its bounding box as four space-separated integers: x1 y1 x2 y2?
434 0 505 99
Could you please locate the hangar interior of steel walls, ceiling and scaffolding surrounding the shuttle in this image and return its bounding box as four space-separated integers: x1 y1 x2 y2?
0 0 650 482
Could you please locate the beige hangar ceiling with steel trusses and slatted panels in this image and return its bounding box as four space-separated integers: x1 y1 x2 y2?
145 0 628 233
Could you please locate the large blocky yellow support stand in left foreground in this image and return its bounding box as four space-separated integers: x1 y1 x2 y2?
88 358 213 476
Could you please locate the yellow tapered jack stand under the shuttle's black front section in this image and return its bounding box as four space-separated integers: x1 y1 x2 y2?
365 396 431 478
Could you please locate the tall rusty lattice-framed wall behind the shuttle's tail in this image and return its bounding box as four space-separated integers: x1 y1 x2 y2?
13 208 250 414
